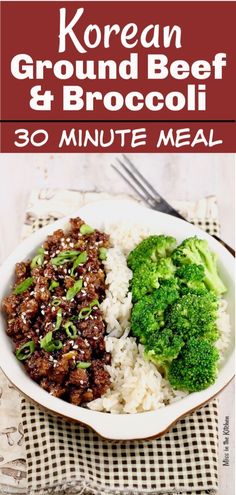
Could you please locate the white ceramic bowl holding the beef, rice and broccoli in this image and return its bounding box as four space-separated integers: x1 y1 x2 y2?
0 200 234 440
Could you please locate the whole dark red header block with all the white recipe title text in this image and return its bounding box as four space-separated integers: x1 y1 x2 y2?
1 1 236 152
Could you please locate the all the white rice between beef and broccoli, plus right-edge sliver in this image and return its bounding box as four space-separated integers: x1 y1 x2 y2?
88 226 230 413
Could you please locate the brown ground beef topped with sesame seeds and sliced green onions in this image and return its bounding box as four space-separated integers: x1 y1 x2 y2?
2 218 111 405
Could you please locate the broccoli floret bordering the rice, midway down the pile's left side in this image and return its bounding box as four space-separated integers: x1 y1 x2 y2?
131 279 179 344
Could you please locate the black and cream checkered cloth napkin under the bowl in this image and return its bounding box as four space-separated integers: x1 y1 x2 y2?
22 194 219 495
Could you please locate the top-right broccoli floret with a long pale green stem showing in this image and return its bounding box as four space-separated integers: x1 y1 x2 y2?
172 237 226 296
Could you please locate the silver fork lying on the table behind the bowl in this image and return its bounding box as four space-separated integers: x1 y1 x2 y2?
111 154 235 257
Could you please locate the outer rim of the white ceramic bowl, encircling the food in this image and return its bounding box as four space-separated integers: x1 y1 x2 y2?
0 199 234 441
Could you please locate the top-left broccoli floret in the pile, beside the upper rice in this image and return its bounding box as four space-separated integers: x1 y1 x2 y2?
127 235 176 270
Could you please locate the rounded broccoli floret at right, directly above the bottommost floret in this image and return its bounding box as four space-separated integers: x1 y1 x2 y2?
166 290 219 342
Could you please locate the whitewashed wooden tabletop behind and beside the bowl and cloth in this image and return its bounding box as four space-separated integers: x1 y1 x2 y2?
0 154 235 495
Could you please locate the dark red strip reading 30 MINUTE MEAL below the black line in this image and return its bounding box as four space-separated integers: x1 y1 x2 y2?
2 122 235 153
